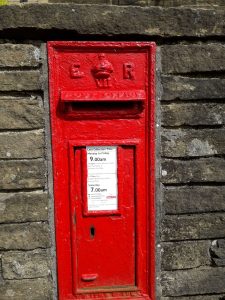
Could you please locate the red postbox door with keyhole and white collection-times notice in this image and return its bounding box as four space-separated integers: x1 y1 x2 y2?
71 146 135 292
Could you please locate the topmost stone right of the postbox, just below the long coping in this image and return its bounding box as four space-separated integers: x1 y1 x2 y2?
161 43 225 74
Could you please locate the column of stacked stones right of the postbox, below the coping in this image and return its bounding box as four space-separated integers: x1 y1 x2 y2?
160 43 225 300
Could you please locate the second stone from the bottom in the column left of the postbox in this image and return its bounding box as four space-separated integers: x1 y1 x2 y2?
2 250 51 279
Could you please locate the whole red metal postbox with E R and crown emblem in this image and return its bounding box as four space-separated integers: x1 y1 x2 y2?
48 42 155 300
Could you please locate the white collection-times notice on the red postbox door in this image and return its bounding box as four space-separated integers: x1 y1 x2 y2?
86 146 118 211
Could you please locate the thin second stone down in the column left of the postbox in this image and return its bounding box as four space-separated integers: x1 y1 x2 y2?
0 70 41 91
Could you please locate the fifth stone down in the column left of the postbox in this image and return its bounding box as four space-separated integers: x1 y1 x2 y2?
0 160 45 190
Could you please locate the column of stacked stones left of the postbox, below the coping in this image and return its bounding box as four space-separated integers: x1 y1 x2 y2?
0 41 53 300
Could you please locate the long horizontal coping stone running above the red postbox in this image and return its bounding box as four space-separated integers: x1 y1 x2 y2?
0 4 225 37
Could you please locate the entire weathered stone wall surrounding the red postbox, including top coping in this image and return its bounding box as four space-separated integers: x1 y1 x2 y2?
0 4 225 300
